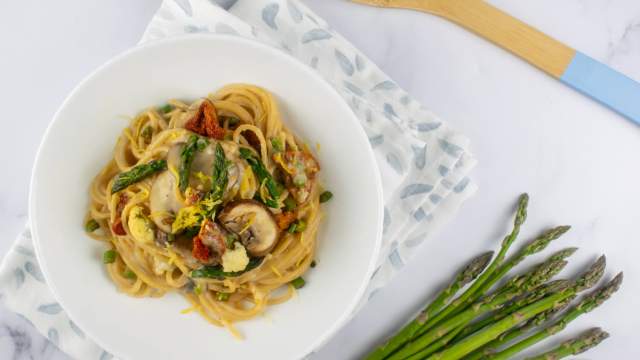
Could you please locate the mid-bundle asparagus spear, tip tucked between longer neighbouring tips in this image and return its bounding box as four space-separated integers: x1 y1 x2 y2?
388 260 566 360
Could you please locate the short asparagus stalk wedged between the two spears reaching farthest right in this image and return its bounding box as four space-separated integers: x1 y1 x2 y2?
465 295 575 360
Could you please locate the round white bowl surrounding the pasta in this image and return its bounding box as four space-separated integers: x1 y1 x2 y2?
29 35 383 359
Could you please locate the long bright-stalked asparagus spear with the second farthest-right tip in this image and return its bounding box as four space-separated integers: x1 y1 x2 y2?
429 256 606 360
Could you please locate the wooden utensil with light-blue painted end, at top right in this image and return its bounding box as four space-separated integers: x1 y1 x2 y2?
351 0 640 125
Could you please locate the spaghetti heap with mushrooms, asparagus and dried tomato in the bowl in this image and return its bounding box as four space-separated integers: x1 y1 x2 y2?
85 84 331 336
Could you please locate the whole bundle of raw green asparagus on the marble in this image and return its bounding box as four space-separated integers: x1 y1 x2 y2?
367 194 622 360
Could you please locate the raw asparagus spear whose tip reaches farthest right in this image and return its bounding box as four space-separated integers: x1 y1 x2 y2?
490 273 623 360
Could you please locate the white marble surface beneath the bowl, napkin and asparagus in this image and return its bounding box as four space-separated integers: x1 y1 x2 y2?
0 0 640 359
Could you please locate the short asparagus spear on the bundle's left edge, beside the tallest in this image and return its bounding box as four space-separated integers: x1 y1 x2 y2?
367 251 493 359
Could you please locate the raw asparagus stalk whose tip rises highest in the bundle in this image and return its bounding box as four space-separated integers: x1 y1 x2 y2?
418 194 529 335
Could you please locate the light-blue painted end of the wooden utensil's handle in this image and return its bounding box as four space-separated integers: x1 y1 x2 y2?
560 52 640 125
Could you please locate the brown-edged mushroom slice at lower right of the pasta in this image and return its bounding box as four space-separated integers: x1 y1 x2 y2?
218 200 280 257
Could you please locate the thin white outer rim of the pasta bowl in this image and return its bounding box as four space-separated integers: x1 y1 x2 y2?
28 33 384 358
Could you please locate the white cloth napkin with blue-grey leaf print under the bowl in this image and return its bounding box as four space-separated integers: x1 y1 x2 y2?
0 0 475 360
